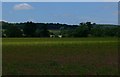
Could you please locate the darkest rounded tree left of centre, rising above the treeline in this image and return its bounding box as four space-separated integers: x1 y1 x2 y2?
23 22 37 37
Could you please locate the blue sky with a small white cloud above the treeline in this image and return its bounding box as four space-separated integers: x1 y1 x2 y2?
2 2 118 24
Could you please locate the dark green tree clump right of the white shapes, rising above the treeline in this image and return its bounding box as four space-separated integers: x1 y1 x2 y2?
61 22 93 37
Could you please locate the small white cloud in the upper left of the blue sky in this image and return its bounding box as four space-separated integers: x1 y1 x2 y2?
13 3 33 10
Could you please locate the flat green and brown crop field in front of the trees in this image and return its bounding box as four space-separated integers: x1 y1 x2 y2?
2 38 118 75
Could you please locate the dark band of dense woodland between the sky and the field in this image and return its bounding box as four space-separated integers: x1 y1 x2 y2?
0 21 120 38
